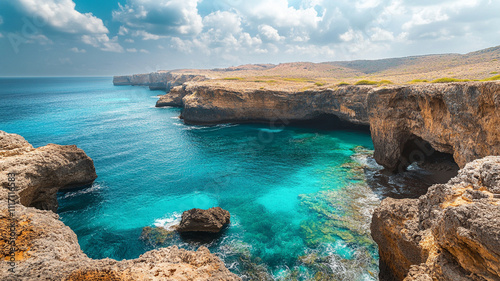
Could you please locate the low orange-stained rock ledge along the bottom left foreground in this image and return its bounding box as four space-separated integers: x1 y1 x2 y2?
0 201 241 281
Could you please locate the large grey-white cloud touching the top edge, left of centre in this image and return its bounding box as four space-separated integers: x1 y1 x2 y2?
113 0 203 36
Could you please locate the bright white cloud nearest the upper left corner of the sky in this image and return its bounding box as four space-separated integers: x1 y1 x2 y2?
18 0 108 34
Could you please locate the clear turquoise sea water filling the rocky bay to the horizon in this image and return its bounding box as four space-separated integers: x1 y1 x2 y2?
0 78 378 280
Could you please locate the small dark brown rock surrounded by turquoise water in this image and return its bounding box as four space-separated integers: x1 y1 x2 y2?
177 207 231 233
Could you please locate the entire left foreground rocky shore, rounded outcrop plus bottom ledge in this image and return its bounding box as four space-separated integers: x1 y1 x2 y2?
0 131 241 281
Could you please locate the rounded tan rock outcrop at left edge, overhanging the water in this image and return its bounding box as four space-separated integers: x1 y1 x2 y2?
0 131 97 211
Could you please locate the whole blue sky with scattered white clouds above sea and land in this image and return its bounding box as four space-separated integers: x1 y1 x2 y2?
0 0 500 76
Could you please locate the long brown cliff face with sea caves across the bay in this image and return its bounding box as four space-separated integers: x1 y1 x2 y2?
157 82 500 171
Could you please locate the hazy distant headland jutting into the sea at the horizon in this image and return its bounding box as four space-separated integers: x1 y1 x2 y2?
113 71 208 91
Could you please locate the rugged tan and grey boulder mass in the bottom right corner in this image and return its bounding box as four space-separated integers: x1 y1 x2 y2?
371 156 500 281
